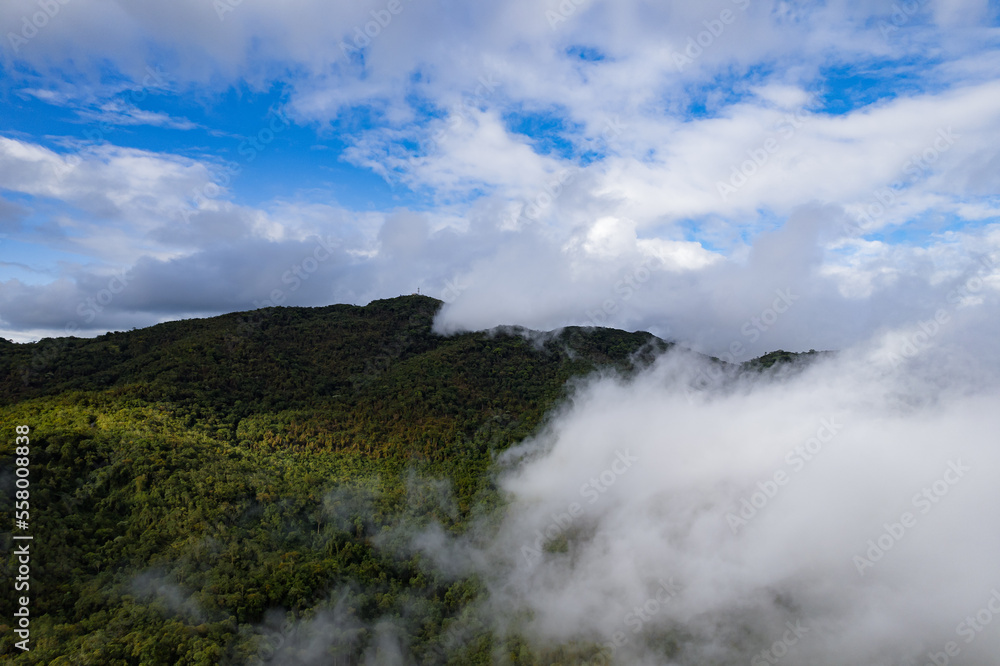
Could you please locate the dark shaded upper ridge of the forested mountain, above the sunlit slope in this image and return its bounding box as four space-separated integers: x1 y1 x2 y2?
0 296 667 420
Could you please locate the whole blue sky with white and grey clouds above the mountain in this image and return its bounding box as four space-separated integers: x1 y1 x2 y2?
0 0 1000 360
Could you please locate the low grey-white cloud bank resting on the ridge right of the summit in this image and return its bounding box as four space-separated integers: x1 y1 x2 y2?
437 206 1000 361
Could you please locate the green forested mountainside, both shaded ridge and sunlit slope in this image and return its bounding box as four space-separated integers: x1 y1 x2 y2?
0 296 808 666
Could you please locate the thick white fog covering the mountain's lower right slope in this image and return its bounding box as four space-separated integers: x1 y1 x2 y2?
420 299 1000 666
